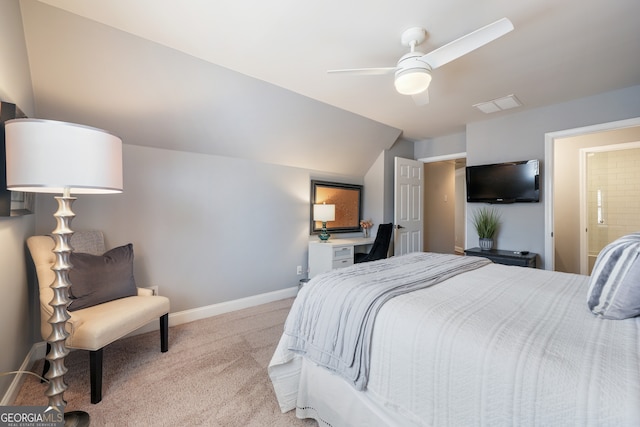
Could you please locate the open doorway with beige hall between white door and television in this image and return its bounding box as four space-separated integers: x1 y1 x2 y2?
423 157 466 254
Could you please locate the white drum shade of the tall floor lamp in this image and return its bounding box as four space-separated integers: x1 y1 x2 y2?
5 119 122 194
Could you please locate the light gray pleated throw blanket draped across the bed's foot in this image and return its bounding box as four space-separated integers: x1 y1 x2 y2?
283 252 491 390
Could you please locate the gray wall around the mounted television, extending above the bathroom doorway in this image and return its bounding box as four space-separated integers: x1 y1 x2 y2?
466 86 640 265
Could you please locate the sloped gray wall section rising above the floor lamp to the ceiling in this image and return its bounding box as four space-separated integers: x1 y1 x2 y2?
21 1 401 177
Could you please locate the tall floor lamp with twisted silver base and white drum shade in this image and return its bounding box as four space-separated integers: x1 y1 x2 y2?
5 119 122 425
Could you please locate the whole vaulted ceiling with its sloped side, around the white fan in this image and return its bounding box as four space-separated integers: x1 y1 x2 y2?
15 0 640 175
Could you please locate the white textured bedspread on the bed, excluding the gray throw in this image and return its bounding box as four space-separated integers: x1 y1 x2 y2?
269 256 640 427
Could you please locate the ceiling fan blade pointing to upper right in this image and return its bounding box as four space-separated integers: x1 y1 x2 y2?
420 18 513 70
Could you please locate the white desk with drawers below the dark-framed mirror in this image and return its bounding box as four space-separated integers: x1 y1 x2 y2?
309 237 375 278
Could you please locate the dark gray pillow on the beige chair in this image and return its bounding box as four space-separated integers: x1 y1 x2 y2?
68 243 138 311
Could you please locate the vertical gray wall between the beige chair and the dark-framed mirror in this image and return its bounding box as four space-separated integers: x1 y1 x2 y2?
36 145 362 312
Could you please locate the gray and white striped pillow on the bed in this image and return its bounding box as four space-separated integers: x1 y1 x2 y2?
587 233 640 320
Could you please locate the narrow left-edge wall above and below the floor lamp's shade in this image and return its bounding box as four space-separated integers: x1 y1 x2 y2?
0 0 36 402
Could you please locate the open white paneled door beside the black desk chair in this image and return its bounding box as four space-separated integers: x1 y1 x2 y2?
393 157 423 256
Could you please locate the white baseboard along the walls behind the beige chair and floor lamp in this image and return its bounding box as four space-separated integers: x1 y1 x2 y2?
0 286 298 406
